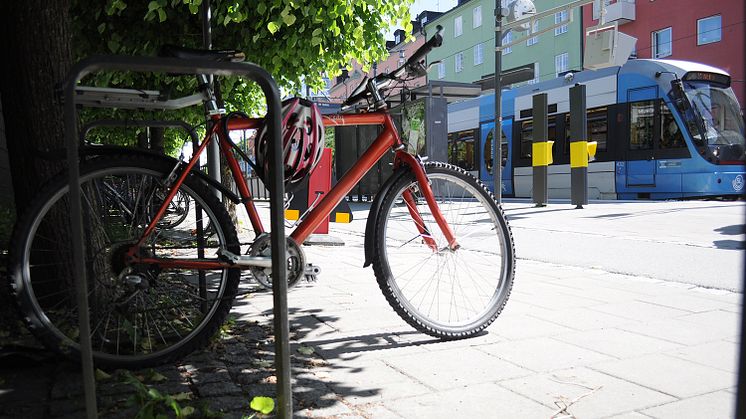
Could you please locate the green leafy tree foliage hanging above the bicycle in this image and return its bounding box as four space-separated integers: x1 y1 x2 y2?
70 0 413 151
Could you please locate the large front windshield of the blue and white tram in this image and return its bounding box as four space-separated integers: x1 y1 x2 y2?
684 81 746 163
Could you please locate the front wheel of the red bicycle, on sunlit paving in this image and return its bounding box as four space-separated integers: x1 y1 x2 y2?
373 163 515 339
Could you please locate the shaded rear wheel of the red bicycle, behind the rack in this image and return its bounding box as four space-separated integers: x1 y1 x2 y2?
9 155 240 369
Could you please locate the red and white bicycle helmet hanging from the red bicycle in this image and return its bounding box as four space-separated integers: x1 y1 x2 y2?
255 97 324 190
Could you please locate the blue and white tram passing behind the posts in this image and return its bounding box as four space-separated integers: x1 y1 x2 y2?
449 60 746 199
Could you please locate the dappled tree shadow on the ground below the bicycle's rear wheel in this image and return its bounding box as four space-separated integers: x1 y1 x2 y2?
0 288 390 419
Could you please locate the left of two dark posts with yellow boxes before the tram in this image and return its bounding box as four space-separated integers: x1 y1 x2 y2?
531 93 552 207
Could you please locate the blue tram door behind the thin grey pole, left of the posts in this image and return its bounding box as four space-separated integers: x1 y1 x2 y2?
479 118 513 195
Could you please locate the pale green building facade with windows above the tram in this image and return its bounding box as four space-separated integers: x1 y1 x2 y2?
422 0 583 88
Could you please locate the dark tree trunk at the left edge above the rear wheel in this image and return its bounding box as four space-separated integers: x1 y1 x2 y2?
0 0 72 214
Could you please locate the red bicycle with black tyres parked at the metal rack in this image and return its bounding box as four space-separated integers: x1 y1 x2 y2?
9 29 515 368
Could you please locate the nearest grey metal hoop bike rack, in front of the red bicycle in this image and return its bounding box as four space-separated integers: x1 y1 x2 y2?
62 56 292 418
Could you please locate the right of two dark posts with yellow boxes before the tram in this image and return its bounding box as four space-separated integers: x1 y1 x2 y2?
570 84 588 209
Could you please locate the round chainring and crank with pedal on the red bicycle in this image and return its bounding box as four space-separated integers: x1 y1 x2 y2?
247 233 321 289
